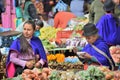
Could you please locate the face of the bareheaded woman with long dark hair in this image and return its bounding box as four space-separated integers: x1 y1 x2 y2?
23 23 34 38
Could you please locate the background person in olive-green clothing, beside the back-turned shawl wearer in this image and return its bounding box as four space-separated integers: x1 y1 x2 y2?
89 0 105 24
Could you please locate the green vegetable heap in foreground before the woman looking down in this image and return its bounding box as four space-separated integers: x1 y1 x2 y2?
76 66 105 80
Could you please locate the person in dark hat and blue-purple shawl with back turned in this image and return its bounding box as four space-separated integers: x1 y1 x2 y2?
96 0 120 46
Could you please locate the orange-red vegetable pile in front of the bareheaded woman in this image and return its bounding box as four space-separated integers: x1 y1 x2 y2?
22 68 51 80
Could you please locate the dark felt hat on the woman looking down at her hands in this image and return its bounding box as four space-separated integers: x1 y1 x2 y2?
83 23 98 36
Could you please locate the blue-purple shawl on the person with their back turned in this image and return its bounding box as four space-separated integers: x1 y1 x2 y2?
96 14 120 45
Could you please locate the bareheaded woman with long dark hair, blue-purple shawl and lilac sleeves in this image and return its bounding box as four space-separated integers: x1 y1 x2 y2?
6 21 48 77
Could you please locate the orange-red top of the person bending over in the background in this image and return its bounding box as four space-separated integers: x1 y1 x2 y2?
54 11 76 28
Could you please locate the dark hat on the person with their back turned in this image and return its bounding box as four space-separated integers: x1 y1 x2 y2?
103 0 115 11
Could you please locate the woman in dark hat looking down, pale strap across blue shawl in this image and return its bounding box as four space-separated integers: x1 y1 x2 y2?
76 23 114 69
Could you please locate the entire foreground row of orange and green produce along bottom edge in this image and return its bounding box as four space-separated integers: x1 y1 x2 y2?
2 64 120 80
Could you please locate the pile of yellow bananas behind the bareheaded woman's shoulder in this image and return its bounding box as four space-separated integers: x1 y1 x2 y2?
39 27 61 40
